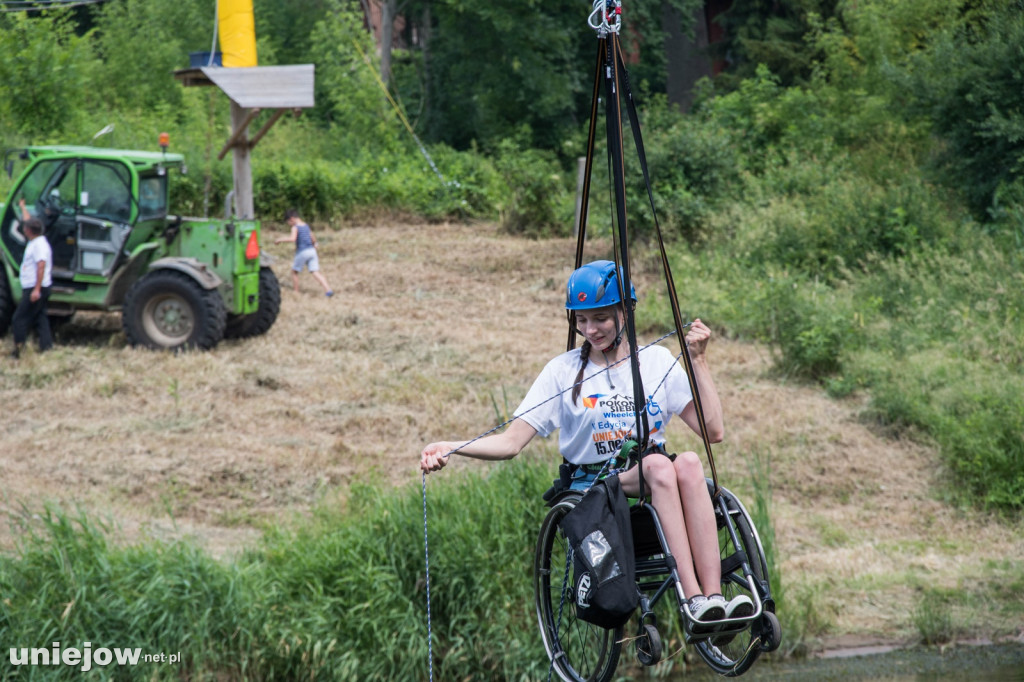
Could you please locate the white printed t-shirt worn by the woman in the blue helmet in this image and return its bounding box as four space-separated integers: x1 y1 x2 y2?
515 346 692 464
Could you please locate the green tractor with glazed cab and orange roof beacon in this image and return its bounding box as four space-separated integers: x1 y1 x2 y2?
0 146 281 349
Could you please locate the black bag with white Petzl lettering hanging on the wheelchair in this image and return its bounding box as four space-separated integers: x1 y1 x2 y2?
562 476 640 628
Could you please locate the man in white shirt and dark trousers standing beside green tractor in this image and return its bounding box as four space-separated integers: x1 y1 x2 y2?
11 218 53 358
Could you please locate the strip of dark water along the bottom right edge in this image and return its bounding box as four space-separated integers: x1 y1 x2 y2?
673 643 1024 682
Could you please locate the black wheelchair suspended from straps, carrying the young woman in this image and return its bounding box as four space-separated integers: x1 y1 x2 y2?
534 471 781 682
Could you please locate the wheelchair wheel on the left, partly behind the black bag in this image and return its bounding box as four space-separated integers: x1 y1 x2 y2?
534 495 623 682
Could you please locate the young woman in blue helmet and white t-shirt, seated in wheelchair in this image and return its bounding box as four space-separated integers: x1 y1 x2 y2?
420 260 754 623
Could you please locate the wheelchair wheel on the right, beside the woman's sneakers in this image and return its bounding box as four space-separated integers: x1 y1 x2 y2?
695 488 781 677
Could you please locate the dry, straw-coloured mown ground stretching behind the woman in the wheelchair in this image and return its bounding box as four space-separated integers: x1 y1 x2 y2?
0 222 1024 645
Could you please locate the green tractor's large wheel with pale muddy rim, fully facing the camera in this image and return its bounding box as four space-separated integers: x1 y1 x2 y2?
121 270 227 350
